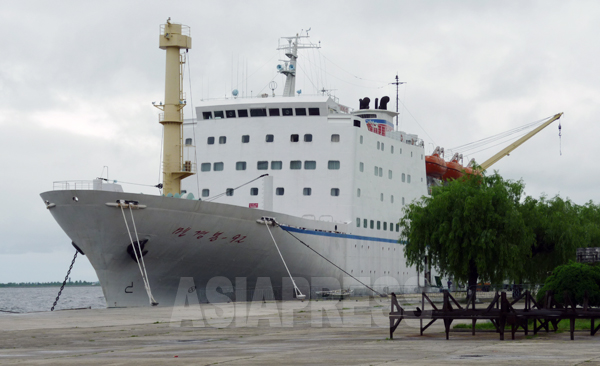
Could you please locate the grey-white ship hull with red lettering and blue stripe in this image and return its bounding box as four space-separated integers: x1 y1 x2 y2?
41 190 416 307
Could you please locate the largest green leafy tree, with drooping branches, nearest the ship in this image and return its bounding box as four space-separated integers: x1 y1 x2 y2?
400 173 534 296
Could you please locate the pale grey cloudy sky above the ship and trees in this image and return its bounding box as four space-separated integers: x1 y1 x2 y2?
0 0 600 282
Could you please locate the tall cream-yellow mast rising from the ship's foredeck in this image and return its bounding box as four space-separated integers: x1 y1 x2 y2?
155 18 195 195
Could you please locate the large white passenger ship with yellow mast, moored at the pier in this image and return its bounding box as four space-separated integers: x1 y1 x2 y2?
41 21 427 307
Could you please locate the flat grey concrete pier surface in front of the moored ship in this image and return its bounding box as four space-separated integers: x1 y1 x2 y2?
0 299 600 365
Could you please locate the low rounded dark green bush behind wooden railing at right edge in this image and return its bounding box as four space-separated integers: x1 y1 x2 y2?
537 261 600 306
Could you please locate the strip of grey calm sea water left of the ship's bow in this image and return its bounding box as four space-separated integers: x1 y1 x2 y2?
0 286 106 313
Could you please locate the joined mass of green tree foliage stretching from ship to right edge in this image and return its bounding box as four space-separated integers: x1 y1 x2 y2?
400 173 600 286
